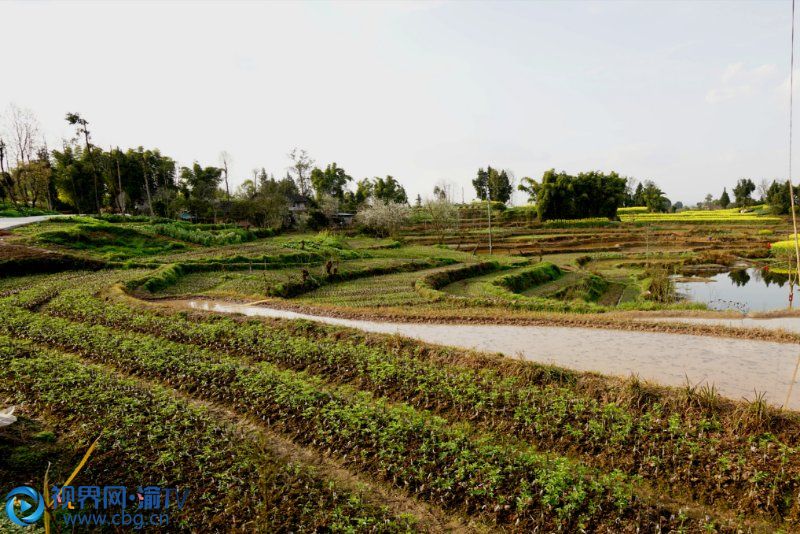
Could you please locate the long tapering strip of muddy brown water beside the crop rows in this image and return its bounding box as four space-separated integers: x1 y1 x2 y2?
179 300 800 410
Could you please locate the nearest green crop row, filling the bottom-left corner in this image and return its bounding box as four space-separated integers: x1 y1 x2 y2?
0 336 413 532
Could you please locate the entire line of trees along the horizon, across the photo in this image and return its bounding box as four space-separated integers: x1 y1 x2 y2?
7 105 797 229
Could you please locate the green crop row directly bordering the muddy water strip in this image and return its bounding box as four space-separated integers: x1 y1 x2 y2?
39 293 800 518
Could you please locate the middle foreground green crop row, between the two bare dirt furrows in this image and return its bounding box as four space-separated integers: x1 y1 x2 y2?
0 306 660 528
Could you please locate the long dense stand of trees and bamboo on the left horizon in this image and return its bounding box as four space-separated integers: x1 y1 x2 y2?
0 105 408 227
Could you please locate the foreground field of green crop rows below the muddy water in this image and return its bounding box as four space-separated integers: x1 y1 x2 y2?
0 271 800 531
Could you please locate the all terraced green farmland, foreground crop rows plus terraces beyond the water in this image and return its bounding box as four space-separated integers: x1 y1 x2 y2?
0 214 800 532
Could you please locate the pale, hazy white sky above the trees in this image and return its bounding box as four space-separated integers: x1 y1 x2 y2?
0 0 800 204
